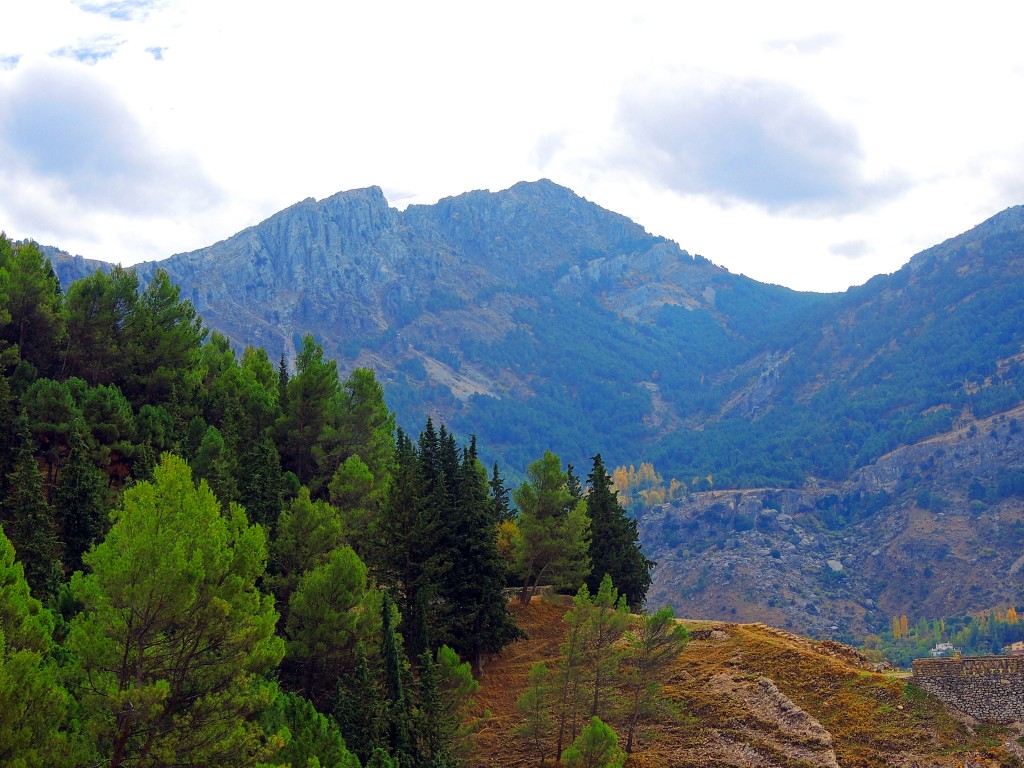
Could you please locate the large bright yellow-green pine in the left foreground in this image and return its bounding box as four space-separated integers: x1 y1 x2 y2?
68 455 284 768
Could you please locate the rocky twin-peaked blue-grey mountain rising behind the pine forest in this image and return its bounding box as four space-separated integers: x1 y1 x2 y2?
56 180 821 470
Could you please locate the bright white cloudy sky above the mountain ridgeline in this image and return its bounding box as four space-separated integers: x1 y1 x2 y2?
0 0 1024 291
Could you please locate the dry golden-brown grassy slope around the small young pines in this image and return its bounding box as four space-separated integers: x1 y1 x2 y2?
471 600 1014 768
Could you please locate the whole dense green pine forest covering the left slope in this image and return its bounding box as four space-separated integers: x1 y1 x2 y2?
0 237 663 768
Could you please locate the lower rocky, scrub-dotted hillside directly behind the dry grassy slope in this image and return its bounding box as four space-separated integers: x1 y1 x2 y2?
640 409 1024 637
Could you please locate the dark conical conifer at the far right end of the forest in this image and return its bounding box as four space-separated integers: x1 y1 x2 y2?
587 454 654 608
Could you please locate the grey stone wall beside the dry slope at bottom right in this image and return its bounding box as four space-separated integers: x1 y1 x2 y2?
913 656 1024 723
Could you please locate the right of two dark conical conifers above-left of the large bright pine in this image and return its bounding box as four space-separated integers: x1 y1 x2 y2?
53 430 109 570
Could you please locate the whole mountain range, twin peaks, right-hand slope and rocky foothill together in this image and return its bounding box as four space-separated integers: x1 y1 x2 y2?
51 180 1024 637
